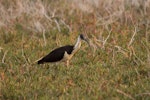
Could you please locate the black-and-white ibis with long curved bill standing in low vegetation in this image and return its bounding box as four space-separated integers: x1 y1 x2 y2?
38 34 89 67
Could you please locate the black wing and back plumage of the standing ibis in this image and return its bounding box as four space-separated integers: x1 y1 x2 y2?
38 45 73 64
